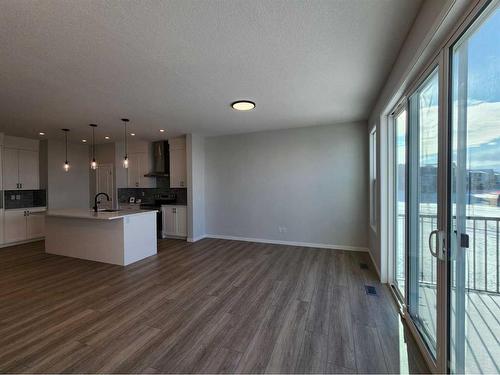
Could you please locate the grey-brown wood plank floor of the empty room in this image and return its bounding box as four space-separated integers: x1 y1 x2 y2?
0 239 428 373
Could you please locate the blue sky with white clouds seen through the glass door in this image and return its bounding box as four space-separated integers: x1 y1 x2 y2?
396 4 500 172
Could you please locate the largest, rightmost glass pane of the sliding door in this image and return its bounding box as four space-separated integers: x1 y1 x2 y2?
449 2 500 373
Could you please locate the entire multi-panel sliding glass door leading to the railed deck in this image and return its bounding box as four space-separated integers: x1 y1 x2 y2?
391 0 500 373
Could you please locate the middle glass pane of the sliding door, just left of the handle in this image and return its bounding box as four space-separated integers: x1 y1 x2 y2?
408 70 439 355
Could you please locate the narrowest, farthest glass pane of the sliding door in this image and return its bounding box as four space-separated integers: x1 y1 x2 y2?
394 110 406 298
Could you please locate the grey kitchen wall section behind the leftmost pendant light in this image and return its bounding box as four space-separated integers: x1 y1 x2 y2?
44 140 89 209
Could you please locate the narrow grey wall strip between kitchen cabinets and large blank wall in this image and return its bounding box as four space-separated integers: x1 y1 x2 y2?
186 134 206 240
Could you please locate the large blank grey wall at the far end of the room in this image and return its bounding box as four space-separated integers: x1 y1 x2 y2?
205 122 368 248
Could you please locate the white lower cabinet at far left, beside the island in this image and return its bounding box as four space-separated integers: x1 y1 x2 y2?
4 207 45 243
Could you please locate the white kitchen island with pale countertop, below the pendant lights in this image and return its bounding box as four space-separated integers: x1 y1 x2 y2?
45 209 157 266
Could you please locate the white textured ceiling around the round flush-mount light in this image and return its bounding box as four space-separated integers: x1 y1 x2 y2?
0 0 421 144
